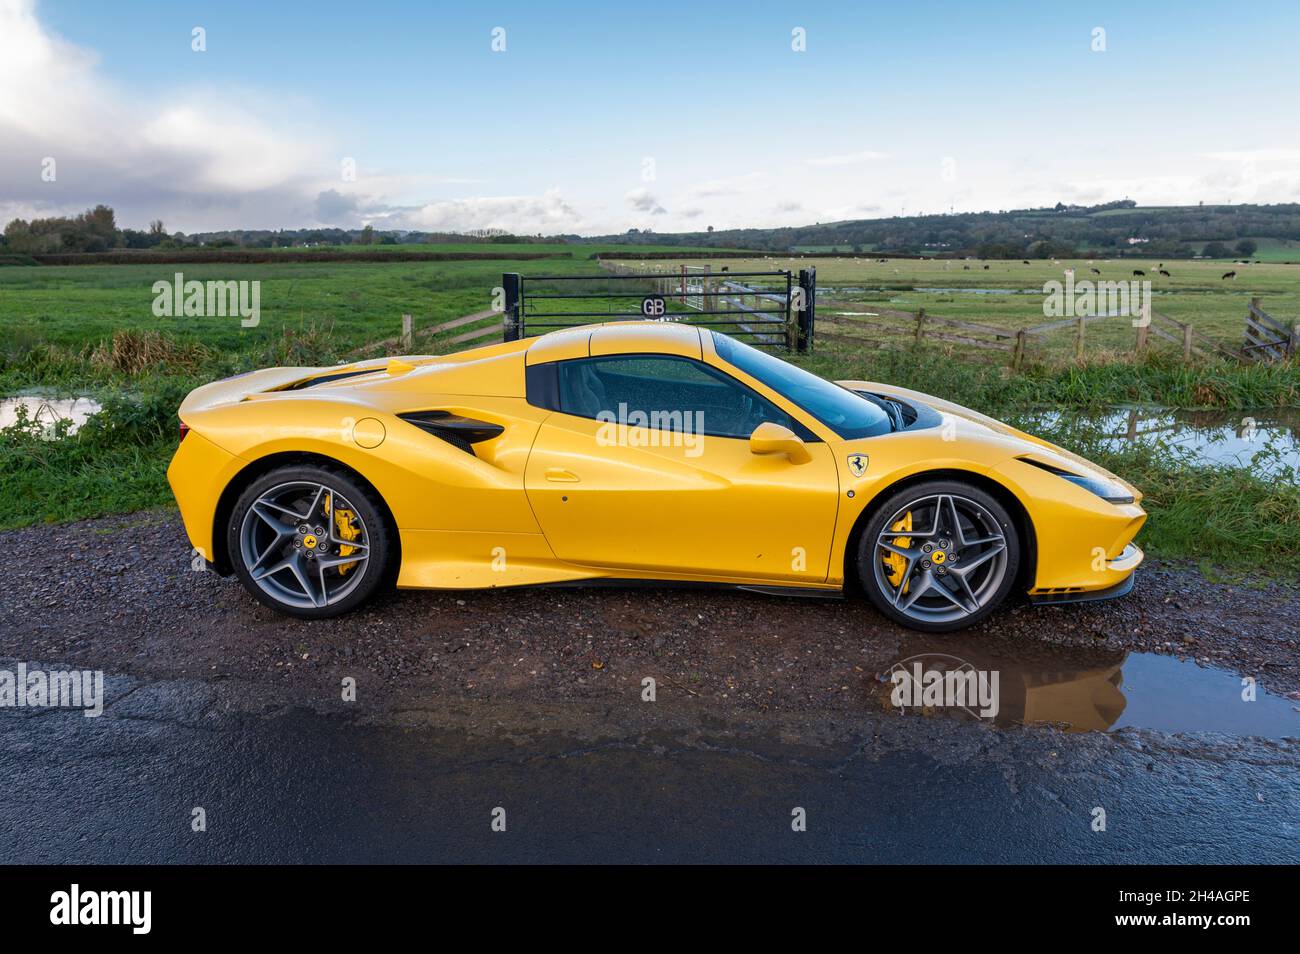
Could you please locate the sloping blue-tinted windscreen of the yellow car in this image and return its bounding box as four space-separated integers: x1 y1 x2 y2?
712 331 893 441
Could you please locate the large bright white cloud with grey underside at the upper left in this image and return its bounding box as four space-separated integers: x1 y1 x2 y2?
0 0 337 230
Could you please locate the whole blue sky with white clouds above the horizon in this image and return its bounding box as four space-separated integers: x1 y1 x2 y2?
0 0 1300 233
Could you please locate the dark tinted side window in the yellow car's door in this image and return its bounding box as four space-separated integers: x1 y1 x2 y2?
558 355 815 439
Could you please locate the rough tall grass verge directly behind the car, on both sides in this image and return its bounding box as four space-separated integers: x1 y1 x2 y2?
0 322 1300 571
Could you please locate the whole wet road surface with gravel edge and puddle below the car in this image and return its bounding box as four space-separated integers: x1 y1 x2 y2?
0 513 1300 863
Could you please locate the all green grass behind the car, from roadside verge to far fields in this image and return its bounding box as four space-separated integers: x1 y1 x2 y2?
0 244 1300 571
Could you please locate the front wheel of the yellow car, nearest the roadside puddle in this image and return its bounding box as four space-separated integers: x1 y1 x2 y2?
858 481 1021 633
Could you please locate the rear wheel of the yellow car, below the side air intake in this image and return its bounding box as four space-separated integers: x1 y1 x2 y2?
228 467 390 619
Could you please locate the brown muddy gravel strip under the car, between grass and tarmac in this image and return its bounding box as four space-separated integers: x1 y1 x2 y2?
0 512 1300 712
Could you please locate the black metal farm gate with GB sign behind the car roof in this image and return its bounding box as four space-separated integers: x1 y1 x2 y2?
502 265 816 352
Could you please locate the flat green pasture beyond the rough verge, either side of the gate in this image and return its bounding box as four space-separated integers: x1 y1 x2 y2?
0 252 1300 354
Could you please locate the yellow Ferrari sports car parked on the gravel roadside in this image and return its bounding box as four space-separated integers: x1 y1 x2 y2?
168 321 1147 632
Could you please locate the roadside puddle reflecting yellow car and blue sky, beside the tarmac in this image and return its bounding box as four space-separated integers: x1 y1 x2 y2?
878 641 1300 738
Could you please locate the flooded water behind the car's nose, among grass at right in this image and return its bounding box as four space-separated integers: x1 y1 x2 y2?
1023 408 1300 473
